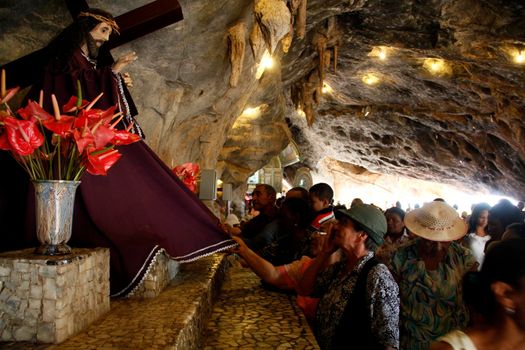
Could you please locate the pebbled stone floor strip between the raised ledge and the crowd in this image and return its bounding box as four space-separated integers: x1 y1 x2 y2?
204 258 319 350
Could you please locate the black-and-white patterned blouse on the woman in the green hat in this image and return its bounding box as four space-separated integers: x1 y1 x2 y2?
314 252 399 349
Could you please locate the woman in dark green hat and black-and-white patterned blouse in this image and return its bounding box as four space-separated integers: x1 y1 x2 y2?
299 204 399 350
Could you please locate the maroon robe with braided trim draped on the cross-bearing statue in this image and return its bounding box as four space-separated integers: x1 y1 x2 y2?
0 50 235 296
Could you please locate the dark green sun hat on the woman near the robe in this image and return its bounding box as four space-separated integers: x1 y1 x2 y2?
335 204 387 245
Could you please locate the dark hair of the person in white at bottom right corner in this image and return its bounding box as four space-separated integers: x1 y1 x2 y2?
463 239 525 322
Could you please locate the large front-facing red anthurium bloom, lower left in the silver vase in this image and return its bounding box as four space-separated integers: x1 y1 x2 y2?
4 117 44 156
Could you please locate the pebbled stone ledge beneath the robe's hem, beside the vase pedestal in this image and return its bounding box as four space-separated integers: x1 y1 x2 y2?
0 253 229 350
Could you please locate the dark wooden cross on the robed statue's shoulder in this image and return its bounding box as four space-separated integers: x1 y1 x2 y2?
2 0 184 88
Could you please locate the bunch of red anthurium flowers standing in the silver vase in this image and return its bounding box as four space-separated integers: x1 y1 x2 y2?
0 70 140 181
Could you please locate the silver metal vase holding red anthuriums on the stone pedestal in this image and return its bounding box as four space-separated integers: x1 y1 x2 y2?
33 180 80 255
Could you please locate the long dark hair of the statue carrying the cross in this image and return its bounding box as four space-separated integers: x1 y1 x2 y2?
47 8 114 72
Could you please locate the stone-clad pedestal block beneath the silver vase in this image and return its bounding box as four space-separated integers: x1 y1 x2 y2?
0 248 109 343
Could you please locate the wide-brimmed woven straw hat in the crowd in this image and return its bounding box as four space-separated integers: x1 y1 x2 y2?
405 201 467 242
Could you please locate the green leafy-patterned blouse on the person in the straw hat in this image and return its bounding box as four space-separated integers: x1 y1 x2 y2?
392 238 476 350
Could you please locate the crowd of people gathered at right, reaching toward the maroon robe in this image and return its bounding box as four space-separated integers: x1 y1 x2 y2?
222 183 525 350
